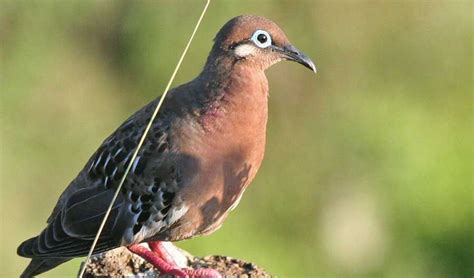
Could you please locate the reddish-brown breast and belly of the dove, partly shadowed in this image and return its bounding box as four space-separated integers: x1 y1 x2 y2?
166 75 268 240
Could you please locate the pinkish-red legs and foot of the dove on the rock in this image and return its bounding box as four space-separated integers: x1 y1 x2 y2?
128 241 222 278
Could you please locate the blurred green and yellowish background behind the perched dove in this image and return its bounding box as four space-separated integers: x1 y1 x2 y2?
0 0 474 277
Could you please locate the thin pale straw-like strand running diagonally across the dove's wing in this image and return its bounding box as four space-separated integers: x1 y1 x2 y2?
78 0 211 278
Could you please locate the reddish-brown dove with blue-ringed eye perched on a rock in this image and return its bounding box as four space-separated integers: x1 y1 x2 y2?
17 15 316 277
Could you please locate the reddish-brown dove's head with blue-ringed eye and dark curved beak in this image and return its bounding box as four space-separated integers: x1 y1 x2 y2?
213 15 316 72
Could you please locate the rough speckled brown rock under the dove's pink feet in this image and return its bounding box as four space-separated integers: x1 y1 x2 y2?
79 248 271 278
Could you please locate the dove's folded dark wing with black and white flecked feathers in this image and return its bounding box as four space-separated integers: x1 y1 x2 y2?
18 98 181 257
